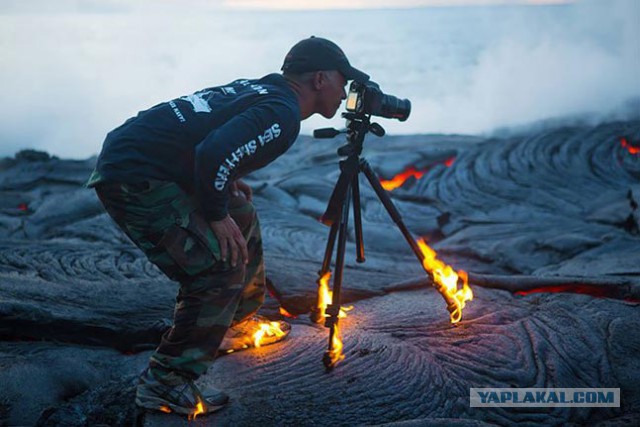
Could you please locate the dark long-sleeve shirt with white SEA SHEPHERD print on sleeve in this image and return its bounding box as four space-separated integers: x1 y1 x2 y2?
90 74 300 220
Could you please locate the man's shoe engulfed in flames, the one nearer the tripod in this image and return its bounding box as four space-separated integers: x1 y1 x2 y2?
218 314 291 354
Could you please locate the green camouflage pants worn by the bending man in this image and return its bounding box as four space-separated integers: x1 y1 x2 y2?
96 181 265 384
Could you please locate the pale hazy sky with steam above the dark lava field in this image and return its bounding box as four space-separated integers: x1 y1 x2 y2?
0 0 640 158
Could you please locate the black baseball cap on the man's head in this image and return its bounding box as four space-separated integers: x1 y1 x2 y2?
281 36 369 83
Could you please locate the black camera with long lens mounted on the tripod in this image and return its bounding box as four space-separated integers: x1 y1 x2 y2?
346 81 411 122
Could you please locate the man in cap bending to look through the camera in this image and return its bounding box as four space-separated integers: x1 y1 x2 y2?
87 37 369 414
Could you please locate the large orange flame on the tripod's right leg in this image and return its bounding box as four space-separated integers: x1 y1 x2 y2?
417 239 473 323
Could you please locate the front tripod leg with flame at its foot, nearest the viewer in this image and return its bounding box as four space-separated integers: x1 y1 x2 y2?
322 185 351 369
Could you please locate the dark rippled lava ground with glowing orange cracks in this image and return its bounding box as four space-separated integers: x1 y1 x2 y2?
0 121 640 426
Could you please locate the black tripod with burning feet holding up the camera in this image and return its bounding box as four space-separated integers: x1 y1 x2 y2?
314 113 455 370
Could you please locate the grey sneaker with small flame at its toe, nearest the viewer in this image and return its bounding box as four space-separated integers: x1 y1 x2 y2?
136 369 229 417
